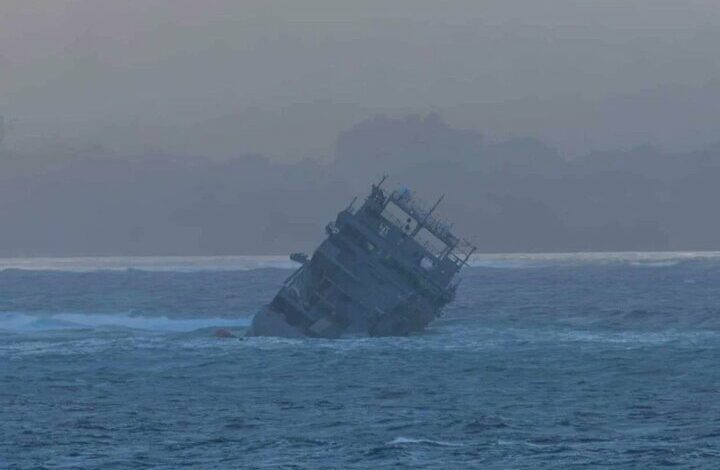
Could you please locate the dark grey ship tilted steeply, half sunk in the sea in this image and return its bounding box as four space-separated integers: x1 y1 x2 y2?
248 178 475 338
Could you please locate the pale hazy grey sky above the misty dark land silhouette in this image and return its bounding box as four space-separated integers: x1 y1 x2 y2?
0 0 720 160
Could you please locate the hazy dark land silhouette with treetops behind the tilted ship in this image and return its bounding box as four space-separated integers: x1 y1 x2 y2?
0 114 720 256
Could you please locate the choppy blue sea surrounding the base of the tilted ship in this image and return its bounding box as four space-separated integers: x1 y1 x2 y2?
0 254 720 469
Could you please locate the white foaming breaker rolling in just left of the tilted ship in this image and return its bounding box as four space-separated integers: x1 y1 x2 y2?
0 312 250 333
